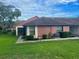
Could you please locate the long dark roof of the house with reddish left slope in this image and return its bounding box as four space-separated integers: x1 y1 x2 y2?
19 16 79 26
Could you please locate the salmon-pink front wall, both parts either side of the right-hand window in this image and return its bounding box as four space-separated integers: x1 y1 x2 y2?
37 26 70 37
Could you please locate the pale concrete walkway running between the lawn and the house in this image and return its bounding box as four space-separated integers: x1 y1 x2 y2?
16 37 79 43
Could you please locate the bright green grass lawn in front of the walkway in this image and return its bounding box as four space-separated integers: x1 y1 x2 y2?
0 35 79 59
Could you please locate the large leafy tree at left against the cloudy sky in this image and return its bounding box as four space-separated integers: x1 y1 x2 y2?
0 2 21 30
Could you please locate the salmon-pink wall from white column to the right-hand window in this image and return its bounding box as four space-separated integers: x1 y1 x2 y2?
37 26 56 37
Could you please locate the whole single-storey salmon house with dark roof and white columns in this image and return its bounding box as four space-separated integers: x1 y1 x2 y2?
16 16 79 38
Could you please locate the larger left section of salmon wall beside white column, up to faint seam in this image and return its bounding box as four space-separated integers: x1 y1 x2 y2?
38 26 50 37
